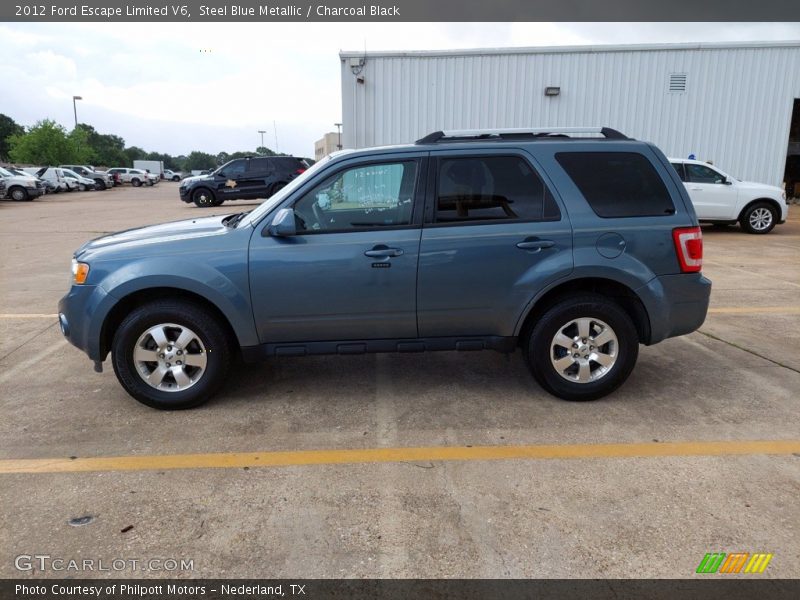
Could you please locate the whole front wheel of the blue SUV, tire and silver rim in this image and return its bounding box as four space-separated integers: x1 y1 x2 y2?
112 300 231 410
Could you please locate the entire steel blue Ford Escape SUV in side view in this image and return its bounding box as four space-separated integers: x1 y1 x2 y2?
59 128 711 409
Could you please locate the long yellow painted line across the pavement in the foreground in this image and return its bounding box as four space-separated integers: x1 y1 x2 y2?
0 440 800 475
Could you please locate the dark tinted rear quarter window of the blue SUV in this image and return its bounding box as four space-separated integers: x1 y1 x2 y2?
556 152 675 218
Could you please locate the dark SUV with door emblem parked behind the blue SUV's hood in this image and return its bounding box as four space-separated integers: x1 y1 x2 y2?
180 156 309 206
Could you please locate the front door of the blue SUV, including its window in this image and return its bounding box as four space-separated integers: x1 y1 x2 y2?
250 153 424 343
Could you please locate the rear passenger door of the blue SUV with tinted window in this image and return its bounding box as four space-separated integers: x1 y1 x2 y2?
417 149 572 337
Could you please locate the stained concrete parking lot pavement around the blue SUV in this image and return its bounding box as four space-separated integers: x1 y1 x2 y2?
0 182 800 578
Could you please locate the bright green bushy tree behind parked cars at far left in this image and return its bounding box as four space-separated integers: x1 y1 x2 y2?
8 119 91 165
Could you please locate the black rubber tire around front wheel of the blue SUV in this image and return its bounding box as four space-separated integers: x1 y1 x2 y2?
111 300 231 410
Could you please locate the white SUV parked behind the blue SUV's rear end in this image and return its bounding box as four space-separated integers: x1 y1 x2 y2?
669 158 789 234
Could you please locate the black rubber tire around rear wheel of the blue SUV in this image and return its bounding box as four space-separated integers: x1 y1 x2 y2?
523 294 639 401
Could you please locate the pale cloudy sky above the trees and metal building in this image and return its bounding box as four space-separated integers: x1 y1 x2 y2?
0 23 800 156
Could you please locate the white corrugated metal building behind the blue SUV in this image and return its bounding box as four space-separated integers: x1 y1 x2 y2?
339 41 800 185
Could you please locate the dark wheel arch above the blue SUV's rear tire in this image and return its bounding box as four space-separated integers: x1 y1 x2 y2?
517 277 651 344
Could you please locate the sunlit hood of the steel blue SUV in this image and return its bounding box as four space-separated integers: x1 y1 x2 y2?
75 215 234 258
